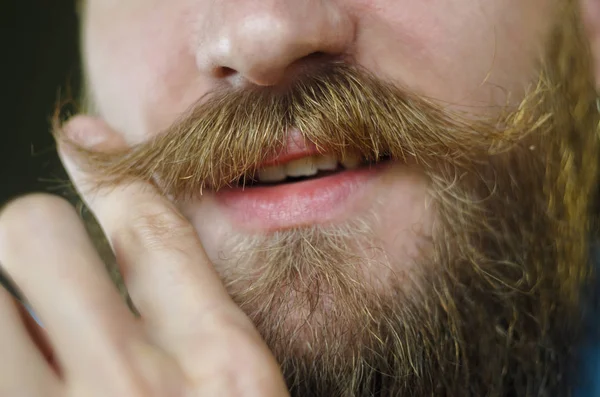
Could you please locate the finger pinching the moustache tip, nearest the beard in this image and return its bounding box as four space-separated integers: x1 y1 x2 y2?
60 118 285 395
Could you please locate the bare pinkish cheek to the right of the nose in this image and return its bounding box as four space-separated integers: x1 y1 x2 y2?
356 0 552 111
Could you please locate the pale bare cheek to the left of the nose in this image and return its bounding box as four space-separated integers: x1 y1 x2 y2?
84 1 208 143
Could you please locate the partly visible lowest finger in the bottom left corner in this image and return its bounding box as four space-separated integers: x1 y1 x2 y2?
0 287 62 397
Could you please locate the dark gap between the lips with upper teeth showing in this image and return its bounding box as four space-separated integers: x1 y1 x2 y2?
237 155 390 188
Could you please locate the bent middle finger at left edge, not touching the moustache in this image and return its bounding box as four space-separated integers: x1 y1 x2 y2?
0 195 139 382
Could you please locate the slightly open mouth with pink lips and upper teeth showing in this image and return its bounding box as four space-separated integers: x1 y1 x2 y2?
214 129 395 229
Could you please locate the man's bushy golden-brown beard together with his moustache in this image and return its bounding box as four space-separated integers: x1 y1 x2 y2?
56 2 599 397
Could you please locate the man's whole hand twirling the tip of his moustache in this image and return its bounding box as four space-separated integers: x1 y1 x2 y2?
0 117 288 397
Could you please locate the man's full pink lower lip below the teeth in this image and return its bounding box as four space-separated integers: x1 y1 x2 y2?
216 165 385 231
